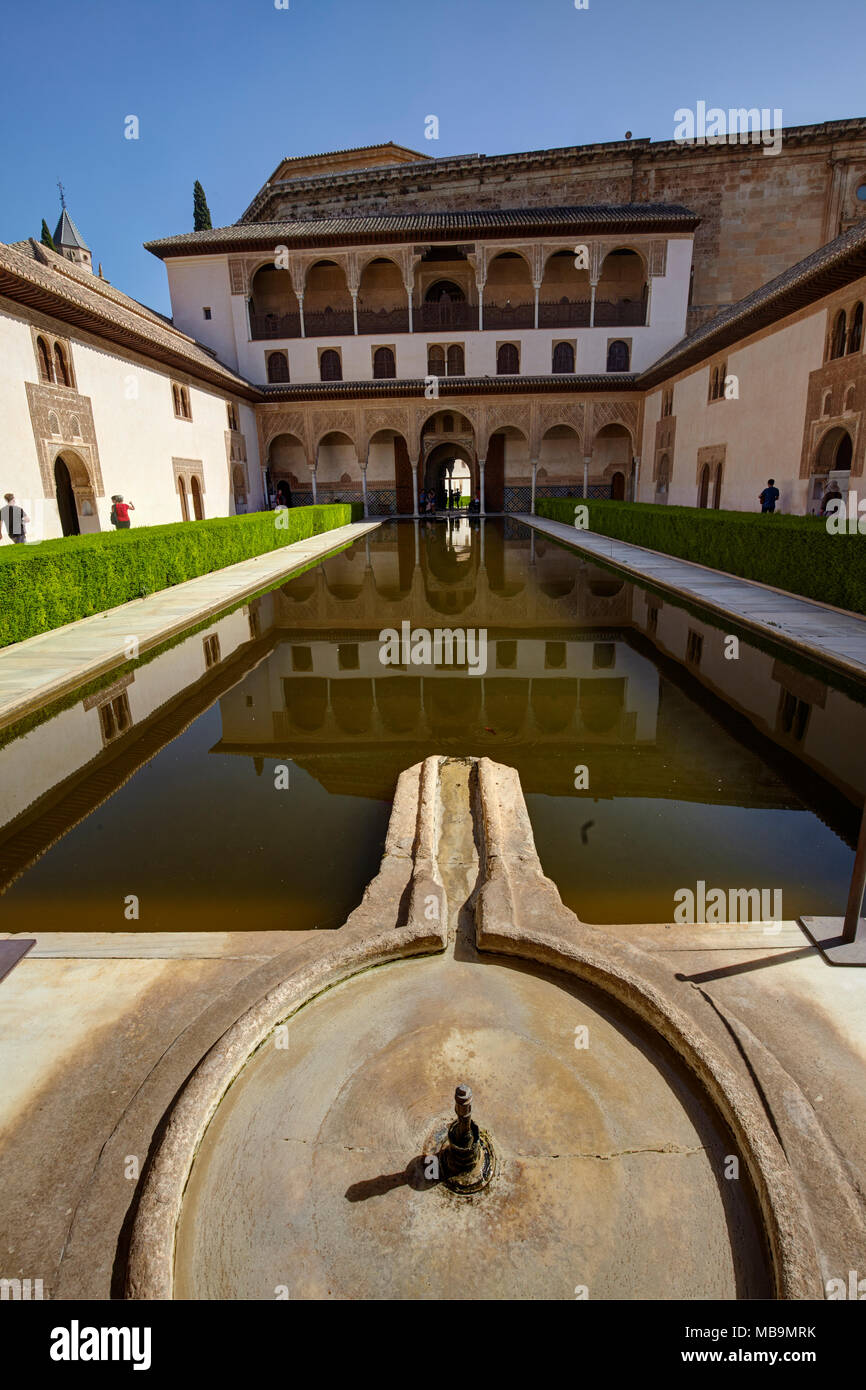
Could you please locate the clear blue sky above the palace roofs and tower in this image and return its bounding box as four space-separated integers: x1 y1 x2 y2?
0 0 866 311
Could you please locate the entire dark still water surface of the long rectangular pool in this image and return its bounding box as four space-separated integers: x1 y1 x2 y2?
0 518 866 931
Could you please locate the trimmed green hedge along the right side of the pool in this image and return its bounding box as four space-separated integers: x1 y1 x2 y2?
535 498 866 613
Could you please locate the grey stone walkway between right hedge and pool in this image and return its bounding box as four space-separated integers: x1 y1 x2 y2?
518 516 866 677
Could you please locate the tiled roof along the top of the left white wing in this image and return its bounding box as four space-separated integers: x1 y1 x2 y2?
0 238 259 400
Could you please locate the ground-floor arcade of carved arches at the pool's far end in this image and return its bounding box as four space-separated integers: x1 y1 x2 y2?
260 393 639 516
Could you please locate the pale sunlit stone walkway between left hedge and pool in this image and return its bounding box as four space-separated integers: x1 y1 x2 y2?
0 520 382 727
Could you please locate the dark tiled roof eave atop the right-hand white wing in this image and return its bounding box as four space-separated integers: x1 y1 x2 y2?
638 218 866 388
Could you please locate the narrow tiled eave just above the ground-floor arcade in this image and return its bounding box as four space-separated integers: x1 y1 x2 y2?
259 371 637 400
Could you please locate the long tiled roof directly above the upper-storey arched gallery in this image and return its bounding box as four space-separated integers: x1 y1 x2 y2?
145 203 701 257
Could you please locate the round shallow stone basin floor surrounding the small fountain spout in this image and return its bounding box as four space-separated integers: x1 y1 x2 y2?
174 949 773 1300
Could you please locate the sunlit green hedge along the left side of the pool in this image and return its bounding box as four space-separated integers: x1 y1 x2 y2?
0 502 363 646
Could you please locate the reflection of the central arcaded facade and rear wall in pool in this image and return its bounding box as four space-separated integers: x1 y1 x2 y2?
214 520 845 806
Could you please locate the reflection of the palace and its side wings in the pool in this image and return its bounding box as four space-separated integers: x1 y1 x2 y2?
0 518 866 887
